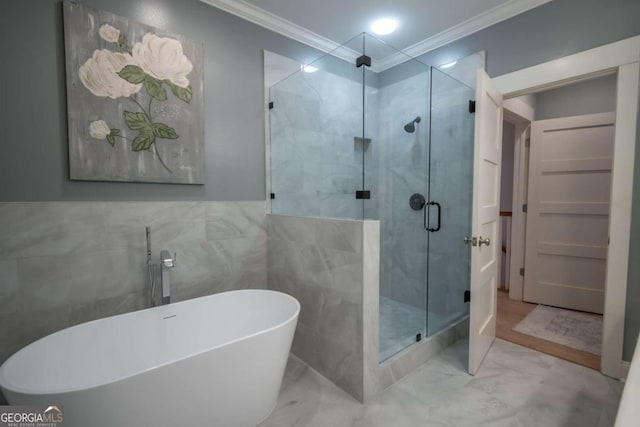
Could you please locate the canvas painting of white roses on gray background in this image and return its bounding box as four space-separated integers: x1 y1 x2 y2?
64 2 204 184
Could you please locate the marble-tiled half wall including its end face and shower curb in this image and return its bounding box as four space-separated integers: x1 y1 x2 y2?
267 215 468 402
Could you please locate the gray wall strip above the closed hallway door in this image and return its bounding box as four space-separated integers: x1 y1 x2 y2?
536 74 617 120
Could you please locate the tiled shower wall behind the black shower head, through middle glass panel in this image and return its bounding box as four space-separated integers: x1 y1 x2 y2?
365 71 429 308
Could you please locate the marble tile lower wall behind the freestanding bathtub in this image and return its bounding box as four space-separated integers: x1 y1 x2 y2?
0 201 267 363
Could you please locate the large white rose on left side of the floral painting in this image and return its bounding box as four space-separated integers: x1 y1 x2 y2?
78 49 142 99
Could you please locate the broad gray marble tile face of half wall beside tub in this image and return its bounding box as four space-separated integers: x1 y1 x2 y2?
267 215 364 400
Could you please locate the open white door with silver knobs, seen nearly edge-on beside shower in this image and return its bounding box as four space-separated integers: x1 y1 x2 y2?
469 70 502 375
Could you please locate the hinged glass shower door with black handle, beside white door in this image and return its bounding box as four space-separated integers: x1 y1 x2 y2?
427 68 475 336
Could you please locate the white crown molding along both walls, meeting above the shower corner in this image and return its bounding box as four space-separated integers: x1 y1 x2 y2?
200 0 552 71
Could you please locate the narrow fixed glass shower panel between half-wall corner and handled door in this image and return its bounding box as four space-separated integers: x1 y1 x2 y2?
364 36 429 361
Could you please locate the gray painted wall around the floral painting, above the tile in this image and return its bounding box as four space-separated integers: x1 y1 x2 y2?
0 0 320 201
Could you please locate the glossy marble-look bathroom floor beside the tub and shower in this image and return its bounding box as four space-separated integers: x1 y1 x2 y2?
260 339 622 427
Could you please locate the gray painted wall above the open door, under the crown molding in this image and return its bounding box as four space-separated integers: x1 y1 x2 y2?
418 0 640 77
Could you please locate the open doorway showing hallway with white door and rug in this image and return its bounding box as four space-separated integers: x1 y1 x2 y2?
496 74 616 369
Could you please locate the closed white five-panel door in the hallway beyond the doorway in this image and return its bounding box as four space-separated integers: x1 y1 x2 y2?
524 113 615 313
